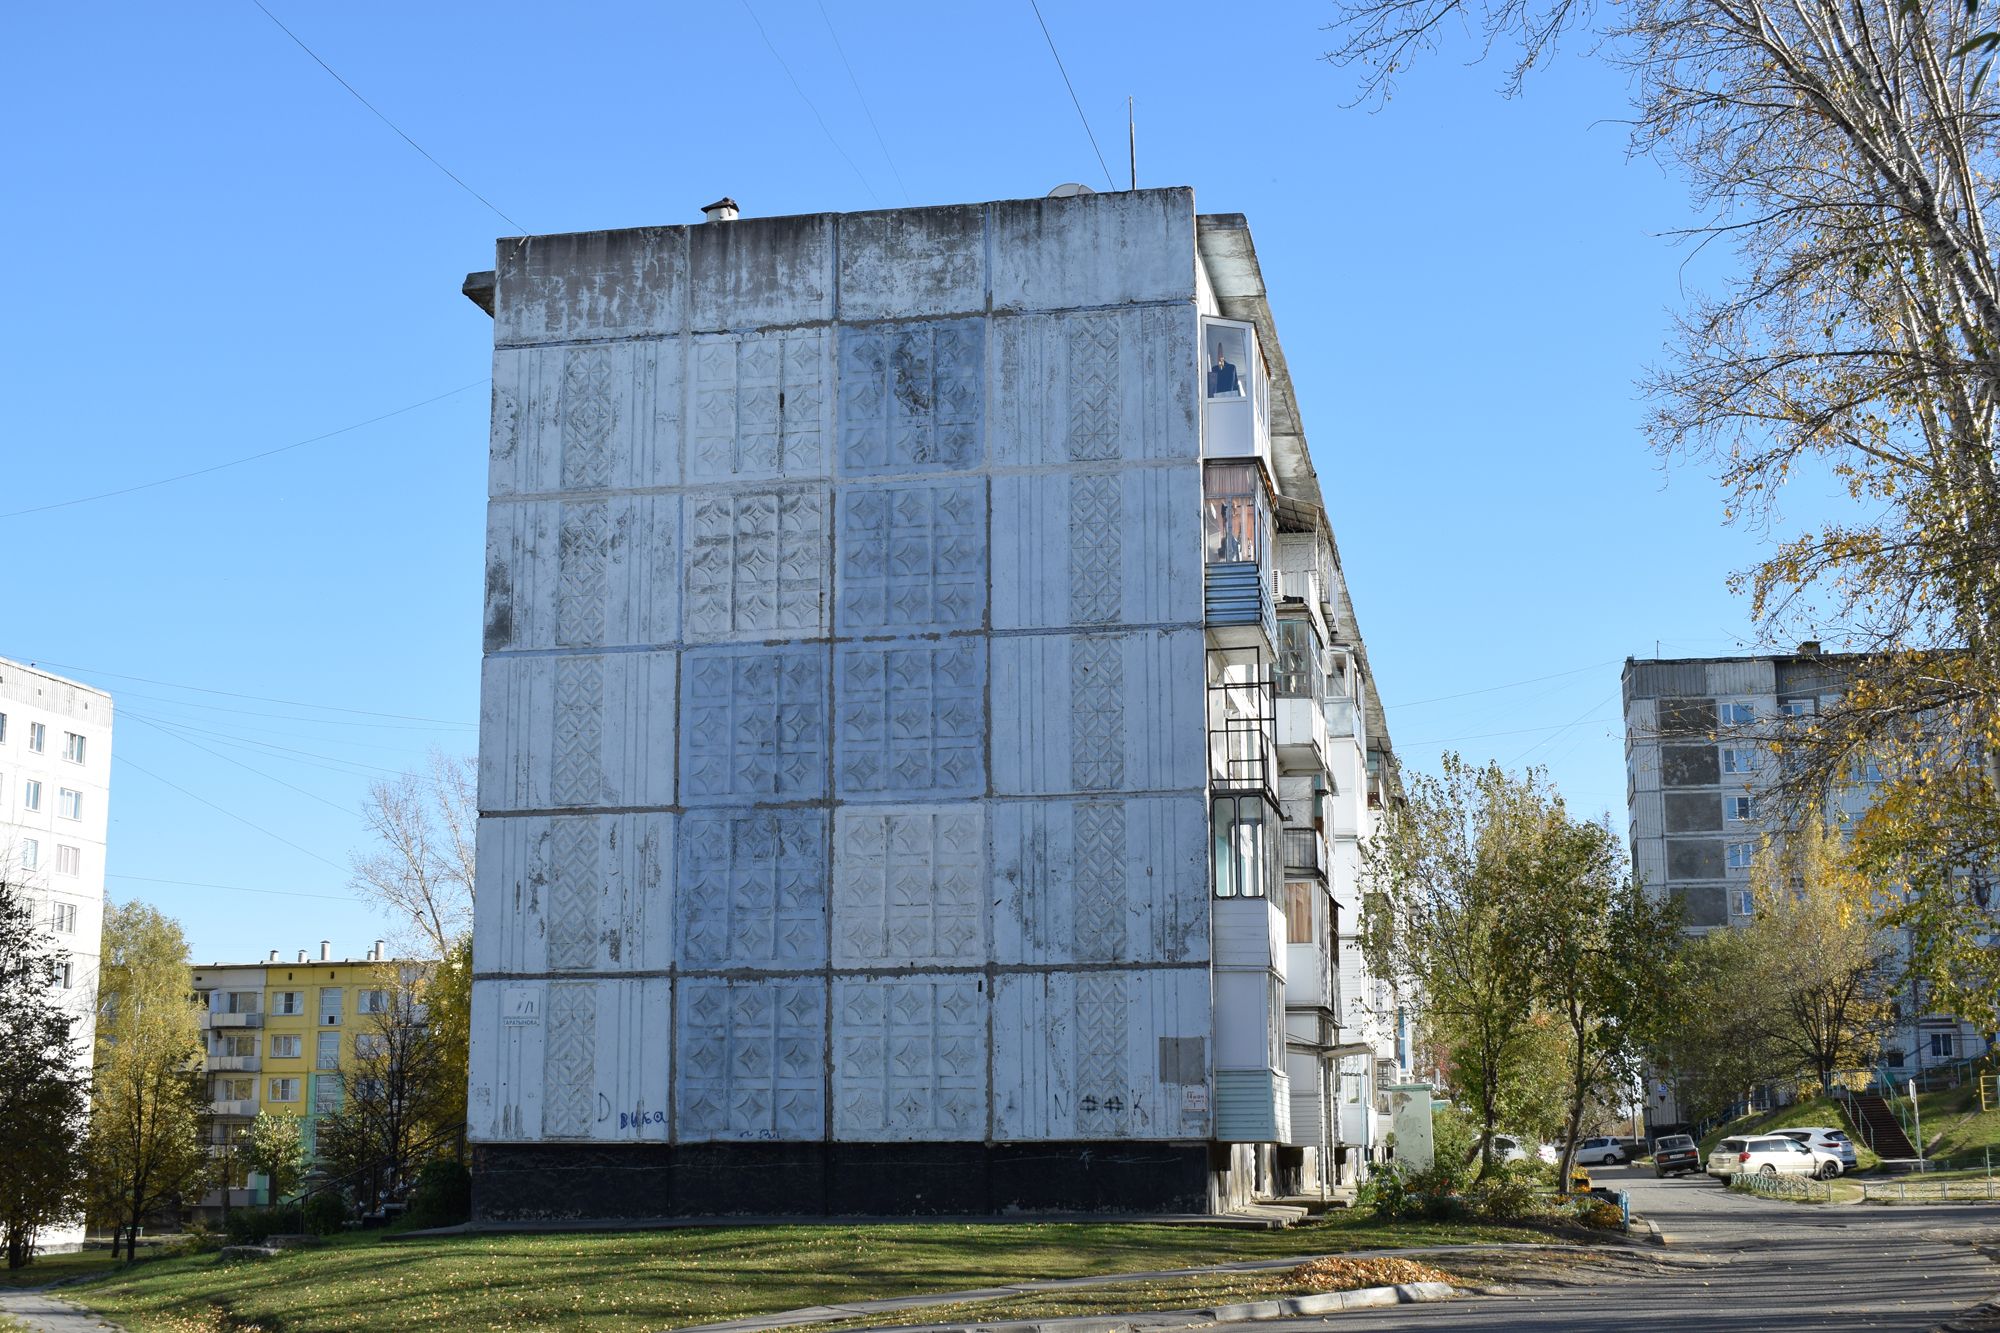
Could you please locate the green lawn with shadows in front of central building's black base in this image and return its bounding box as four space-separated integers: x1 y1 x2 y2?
64 1211 1550 1333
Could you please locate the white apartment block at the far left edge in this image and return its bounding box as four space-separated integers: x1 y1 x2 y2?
0 658 112 1251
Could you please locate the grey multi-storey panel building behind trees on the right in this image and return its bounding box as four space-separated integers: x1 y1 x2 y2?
1624 642 1986 1121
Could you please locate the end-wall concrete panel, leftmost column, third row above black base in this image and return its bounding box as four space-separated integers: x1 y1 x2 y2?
480 652 676 811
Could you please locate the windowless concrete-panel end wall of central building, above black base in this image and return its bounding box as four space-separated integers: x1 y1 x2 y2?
470 190 1212 1211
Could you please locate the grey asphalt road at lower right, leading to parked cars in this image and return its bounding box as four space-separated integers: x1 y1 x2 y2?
1256 1167 2000 1333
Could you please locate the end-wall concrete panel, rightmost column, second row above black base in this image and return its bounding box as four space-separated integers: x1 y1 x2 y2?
990 795 1208 965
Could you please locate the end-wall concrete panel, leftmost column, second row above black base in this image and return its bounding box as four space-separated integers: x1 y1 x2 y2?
474 815 674 973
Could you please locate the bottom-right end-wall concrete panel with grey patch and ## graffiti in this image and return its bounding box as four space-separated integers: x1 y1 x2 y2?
992 967 1210 1141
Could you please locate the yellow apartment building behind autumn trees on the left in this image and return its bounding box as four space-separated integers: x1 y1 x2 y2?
194 941 412 1211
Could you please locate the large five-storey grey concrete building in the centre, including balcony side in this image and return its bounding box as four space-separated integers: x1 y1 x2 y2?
466 190 1408 1219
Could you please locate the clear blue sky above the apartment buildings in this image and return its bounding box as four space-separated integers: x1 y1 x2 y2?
0 0 1800 961
